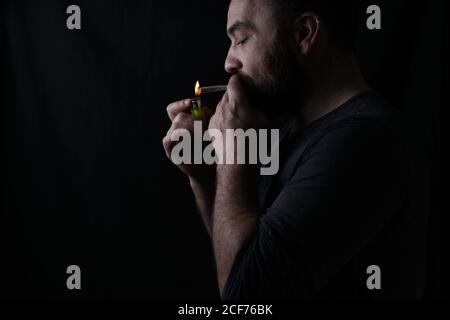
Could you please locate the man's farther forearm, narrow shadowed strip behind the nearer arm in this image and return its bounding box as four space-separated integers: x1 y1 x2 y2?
189 175 216 236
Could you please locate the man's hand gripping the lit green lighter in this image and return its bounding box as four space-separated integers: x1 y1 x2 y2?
163 99 214 181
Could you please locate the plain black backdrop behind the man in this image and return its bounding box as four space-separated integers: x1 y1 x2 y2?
0 0 446 299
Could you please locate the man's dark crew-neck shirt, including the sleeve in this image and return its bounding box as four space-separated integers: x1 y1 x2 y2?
223 92 426 299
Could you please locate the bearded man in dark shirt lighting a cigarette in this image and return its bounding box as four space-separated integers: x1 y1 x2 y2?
163 0 426 299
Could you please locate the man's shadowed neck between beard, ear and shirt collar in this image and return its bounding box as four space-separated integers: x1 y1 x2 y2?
297 53 370 127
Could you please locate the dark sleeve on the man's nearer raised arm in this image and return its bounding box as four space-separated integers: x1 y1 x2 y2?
222 118 405 300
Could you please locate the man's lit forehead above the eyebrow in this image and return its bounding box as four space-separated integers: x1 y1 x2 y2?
227 0 273 28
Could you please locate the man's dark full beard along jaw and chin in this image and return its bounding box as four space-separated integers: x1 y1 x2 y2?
238 37 308 119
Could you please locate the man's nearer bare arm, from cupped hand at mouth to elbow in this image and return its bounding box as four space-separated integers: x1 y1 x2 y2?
209 75 264 294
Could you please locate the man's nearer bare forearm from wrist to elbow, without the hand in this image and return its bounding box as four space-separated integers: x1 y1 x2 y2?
212 165 258 293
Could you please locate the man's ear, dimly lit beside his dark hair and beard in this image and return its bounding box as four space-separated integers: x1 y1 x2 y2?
294 12 321 55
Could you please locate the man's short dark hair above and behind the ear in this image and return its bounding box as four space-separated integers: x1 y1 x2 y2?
269 0 361 49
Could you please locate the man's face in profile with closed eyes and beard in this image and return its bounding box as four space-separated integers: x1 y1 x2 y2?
225 0 305 116
